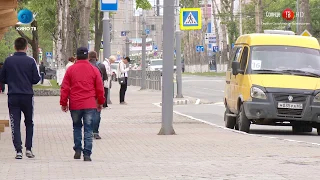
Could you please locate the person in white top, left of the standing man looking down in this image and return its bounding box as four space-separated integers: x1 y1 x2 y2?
103 56 116 108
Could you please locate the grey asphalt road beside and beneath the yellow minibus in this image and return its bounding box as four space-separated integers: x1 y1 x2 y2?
174 76 320 144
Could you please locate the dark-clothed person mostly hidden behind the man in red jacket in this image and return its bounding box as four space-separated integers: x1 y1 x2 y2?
89 51 108 139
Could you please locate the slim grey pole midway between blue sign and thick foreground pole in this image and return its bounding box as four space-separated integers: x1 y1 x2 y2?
141 10 147 90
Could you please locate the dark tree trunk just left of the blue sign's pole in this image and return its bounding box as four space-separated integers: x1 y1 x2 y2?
94 0 103 54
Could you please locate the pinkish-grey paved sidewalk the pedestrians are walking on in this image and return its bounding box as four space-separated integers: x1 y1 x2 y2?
0 86 320 180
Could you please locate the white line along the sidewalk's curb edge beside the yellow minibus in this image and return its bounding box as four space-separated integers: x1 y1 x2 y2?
153 103 320 146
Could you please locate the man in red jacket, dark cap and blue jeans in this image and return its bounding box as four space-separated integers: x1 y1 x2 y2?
60 47 105 161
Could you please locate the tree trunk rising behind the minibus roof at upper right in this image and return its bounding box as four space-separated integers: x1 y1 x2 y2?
299 0 312 33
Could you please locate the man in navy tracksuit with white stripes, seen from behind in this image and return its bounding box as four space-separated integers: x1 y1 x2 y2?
0 37 40 159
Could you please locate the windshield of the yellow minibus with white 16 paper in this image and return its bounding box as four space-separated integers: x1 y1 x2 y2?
250 46 320 74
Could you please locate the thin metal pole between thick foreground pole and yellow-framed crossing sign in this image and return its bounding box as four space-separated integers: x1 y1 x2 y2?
176 0 183 98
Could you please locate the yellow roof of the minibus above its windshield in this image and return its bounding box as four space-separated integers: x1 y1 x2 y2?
235 33 320 50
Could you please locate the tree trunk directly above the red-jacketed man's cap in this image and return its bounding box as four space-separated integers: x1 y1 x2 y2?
78 0 92 47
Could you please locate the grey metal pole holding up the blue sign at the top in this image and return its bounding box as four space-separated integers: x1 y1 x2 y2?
103 12 112 104
